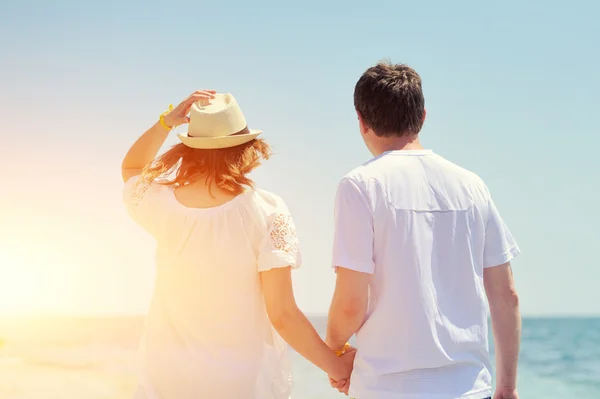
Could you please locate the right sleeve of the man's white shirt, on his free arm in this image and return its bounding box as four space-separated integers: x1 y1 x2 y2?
483 198 521 267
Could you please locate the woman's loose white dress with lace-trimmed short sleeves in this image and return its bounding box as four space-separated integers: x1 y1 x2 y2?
124 176 301 399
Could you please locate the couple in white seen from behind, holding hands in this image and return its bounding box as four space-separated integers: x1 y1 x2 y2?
122 63 521 399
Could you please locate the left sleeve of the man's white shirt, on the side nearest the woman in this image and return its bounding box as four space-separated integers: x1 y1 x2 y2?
332 178 375 274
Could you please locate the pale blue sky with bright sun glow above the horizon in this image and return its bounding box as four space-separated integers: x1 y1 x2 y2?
0 0 600 315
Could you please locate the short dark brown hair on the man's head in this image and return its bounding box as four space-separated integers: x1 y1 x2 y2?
354 62 425 137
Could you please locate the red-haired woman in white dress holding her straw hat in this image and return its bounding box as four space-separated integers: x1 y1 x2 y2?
122 90 350 399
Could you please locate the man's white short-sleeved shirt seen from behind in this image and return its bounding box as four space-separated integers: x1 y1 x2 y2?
333 150 519 399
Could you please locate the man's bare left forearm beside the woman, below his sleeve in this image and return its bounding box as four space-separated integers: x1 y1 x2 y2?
325 267 371 350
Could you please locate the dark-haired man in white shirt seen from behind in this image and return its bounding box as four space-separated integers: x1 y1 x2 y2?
327 63 521 399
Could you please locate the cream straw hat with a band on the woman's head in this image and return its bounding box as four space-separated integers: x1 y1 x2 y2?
177 93 262 149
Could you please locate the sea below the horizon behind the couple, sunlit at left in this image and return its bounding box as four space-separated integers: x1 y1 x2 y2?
0 316 600 399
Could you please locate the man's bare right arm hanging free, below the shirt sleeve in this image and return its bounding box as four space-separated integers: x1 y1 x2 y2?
483 262 521 397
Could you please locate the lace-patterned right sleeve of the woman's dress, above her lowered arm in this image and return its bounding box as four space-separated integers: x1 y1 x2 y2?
258 203 302 272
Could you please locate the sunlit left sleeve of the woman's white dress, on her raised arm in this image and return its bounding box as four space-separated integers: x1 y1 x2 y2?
123 175 168 237
